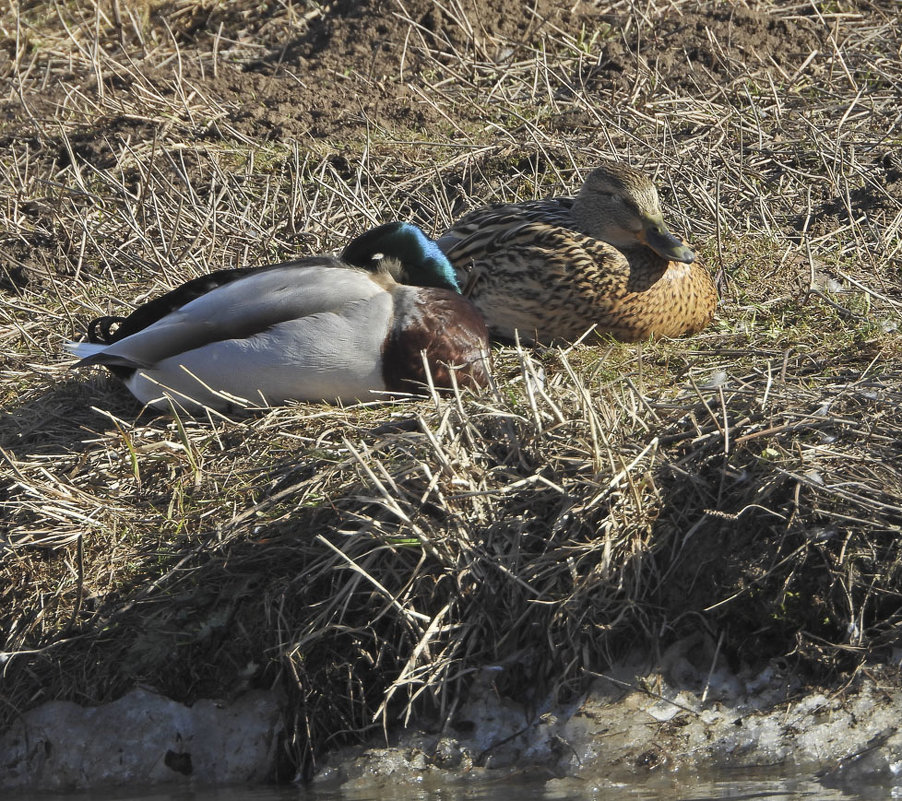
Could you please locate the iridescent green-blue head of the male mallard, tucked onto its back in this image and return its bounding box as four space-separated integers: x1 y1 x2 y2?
341 222 460 293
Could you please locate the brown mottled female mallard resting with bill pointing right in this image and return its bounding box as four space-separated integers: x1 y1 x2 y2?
438 164 717 342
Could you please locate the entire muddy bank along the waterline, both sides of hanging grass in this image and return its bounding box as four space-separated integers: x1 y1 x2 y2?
0 638 902 793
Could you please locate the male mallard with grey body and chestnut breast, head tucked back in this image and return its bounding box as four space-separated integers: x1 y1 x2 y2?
66 223 488 411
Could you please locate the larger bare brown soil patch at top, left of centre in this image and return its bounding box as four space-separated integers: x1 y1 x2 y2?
196 0 608 138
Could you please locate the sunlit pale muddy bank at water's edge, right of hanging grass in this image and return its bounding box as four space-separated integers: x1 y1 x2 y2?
314 643 902 789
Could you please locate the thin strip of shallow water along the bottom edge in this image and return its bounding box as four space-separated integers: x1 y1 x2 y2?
10 772 902 801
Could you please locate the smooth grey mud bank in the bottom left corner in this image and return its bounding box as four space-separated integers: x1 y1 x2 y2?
0 689 282 791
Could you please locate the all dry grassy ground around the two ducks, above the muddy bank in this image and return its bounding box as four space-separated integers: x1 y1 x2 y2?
0 0 902 776
